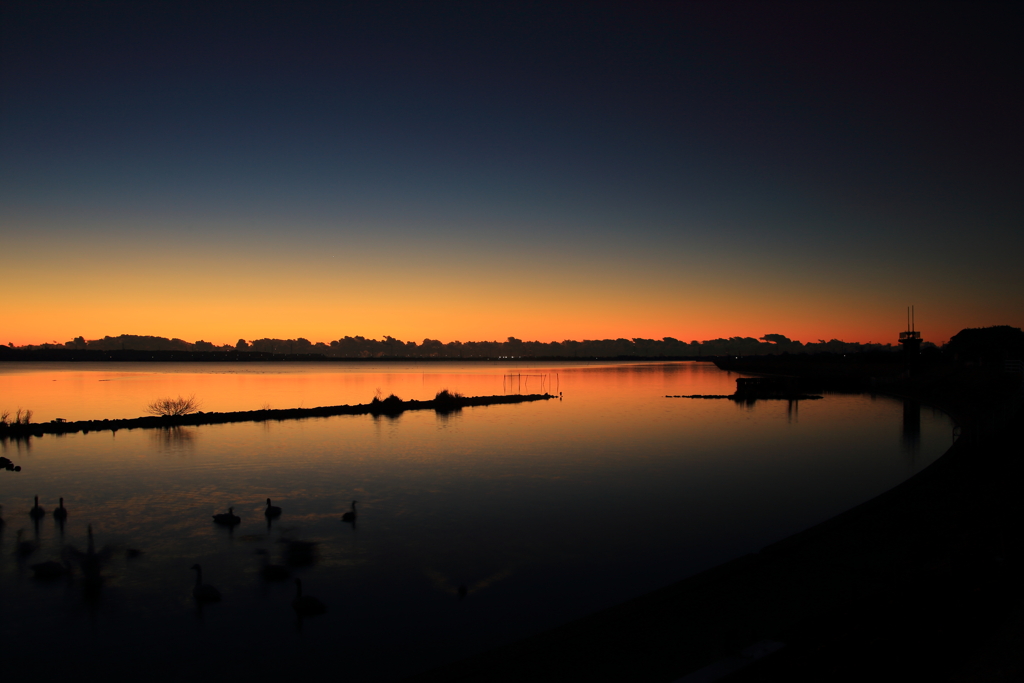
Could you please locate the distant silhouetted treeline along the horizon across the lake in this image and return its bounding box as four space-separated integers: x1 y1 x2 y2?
11 334 921 359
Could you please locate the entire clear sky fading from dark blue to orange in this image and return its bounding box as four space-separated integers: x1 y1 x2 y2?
0 1 1024 345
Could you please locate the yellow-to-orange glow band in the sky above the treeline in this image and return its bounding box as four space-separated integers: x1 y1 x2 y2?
0 227 1024 346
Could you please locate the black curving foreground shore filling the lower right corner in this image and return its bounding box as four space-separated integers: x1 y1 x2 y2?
401 360 1024 683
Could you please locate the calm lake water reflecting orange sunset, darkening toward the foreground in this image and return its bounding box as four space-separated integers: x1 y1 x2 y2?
0 361 952 681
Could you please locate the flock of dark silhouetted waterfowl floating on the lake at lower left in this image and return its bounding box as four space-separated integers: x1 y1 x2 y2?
0 496 358 616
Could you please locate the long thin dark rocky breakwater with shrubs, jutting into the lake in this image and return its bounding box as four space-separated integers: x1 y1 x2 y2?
0 393 556 438
